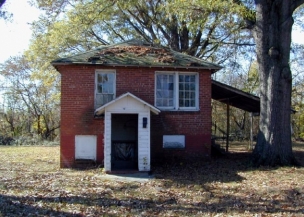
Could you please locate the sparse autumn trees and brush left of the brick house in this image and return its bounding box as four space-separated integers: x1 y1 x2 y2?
0 56 60 139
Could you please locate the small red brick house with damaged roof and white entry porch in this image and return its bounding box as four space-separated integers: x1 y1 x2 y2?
52 40 221 172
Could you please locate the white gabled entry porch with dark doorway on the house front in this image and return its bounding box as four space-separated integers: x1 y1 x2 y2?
95 93 160 172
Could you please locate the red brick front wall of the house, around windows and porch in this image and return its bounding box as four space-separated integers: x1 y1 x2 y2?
57 65 211 167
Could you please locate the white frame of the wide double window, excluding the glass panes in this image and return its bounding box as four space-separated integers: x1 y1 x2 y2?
154 71 199 111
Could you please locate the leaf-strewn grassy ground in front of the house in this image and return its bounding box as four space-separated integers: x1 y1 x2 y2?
0 144 304 217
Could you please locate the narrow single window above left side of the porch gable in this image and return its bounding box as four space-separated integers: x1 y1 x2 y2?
95 71 116 108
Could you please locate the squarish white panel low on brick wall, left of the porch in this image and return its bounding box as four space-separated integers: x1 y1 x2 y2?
75 135 97 160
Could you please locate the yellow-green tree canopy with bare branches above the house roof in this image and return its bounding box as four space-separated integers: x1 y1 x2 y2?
28 0 254 64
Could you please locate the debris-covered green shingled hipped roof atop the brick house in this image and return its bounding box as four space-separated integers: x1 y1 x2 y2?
51 40 222 72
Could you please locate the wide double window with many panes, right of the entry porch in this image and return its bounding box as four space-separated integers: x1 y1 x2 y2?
155 72 198 110
